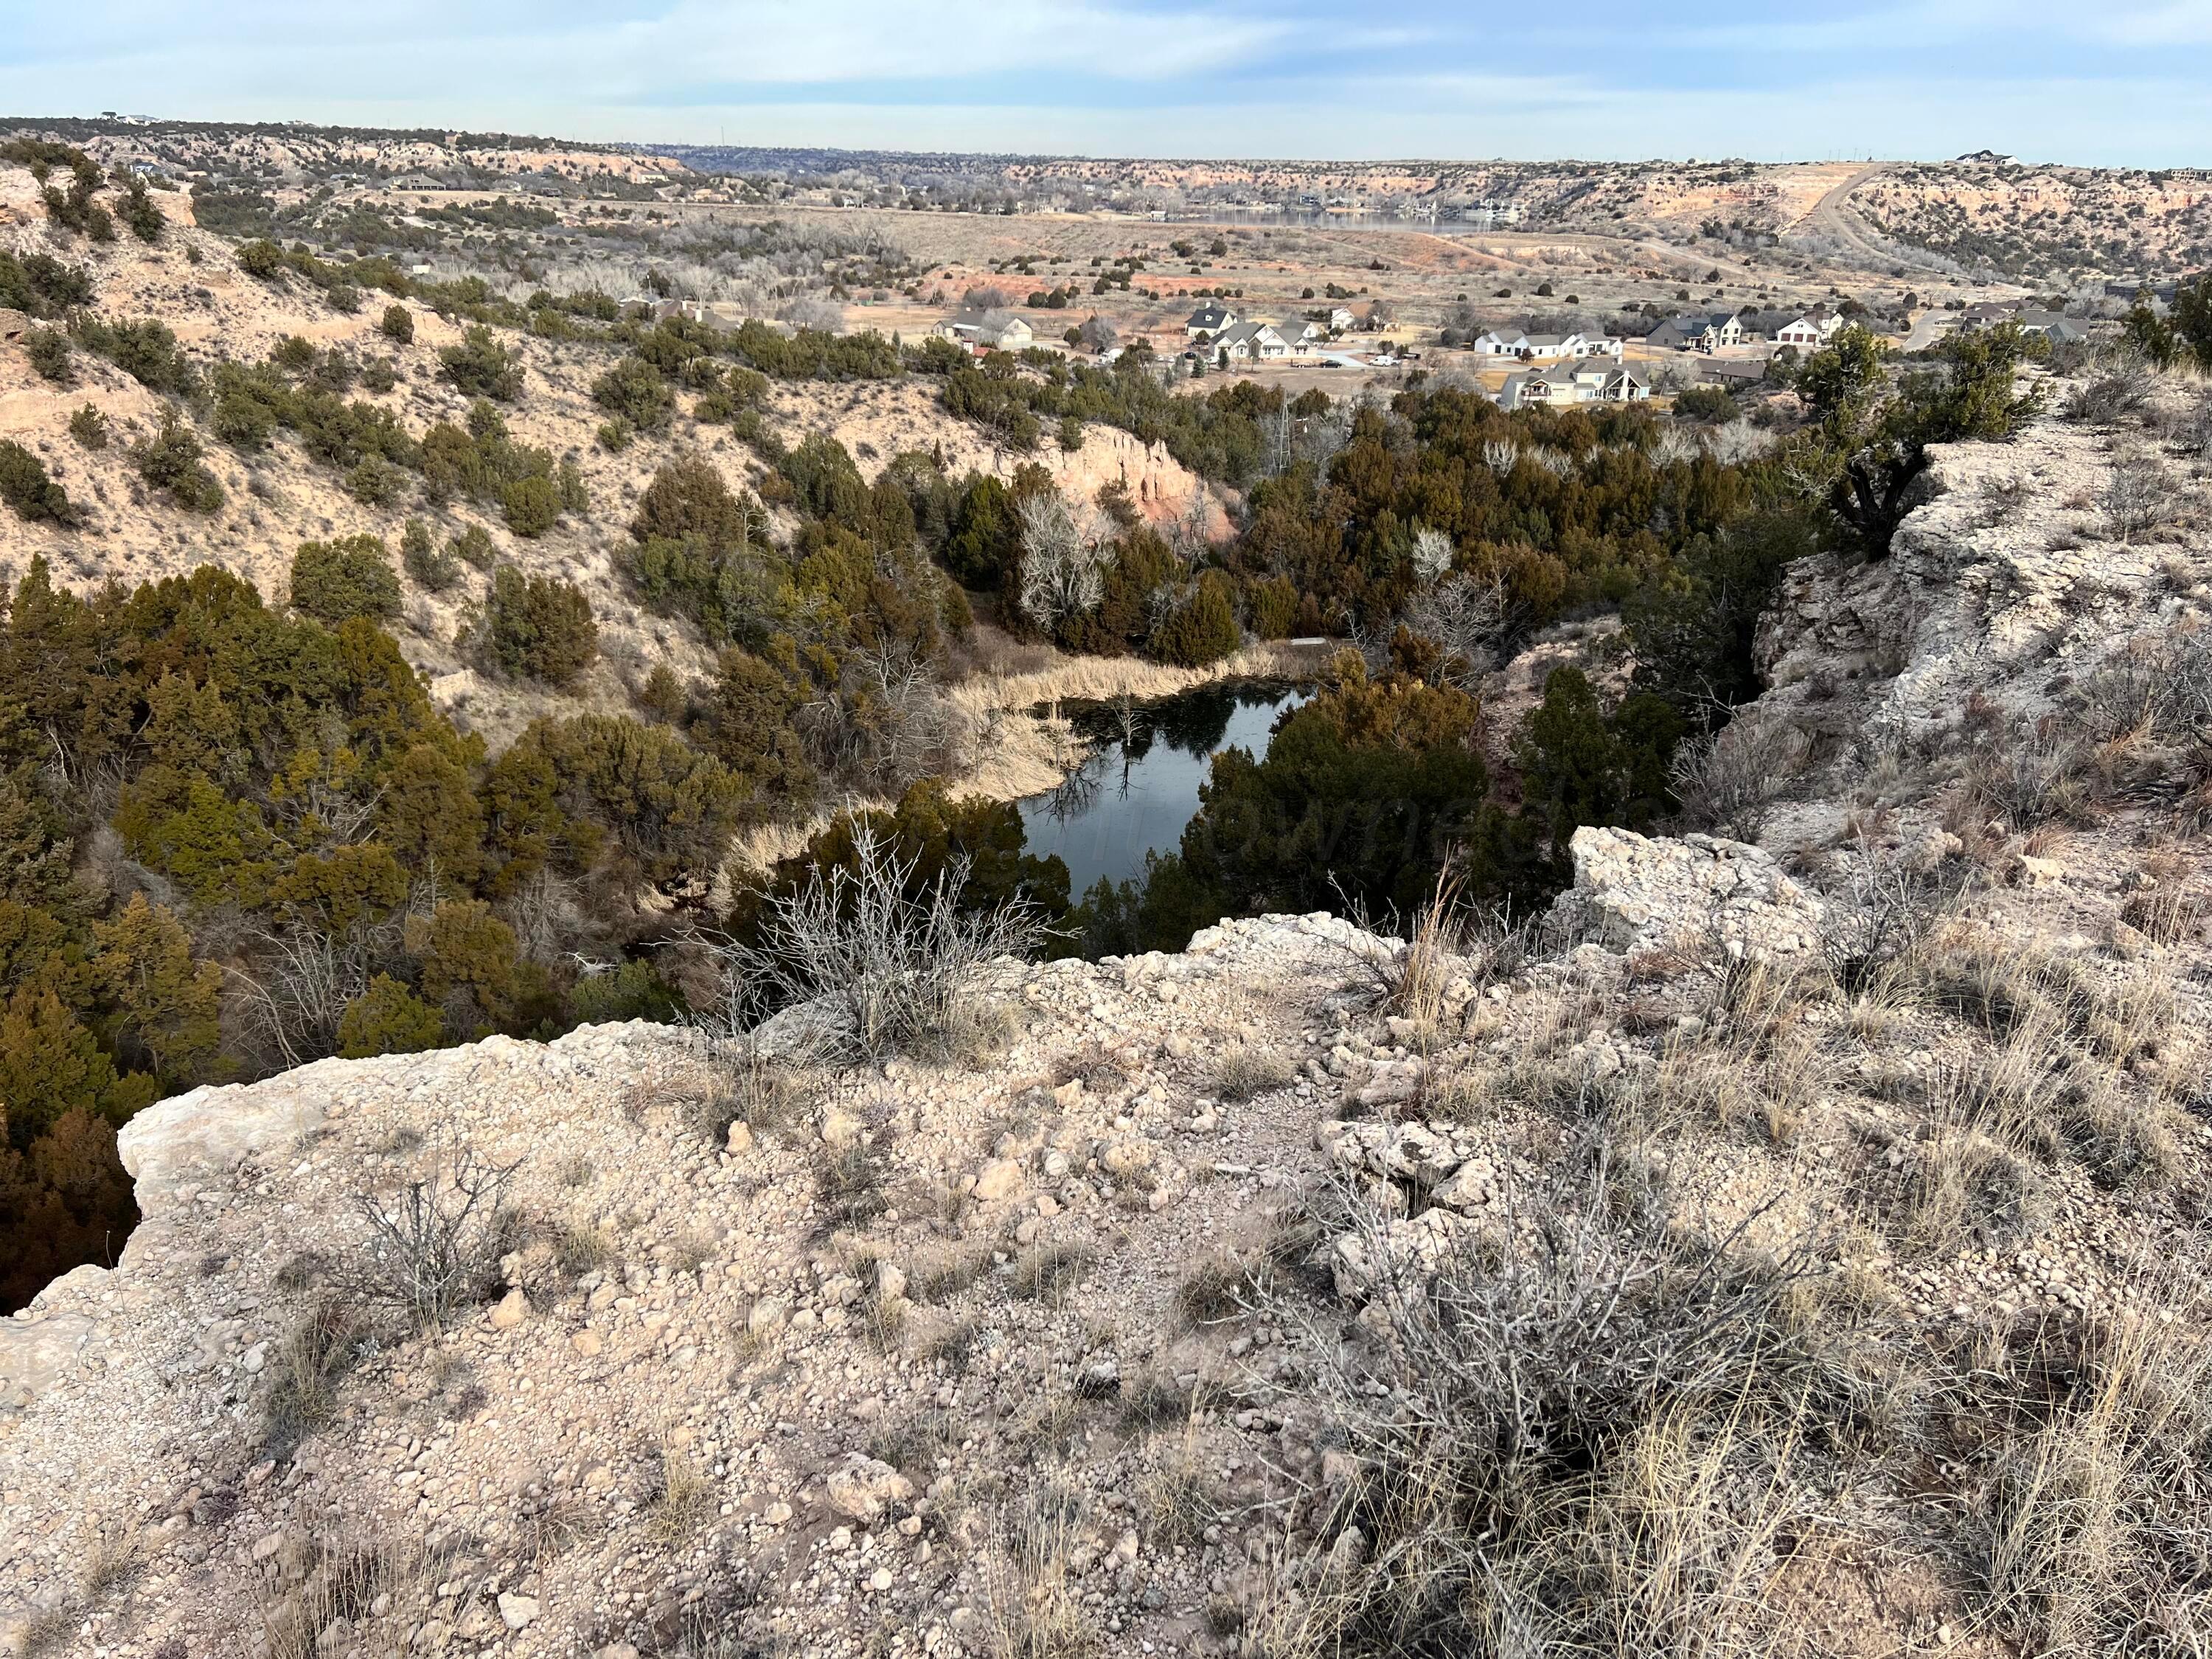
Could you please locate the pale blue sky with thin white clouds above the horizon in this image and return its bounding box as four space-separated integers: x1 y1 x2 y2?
0 0 2212 166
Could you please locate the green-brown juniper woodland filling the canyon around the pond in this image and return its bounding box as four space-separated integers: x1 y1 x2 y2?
0 136 2088 1327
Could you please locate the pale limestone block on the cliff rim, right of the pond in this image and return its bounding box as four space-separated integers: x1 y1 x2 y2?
1551 827 1825 960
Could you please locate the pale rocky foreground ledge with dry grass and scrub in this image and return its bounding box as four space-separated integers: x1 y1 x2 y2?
0 367 2212 1659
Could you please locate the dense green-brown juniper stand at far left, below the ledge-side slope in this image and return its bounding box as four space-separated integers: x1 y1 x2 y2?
0 562 759 1303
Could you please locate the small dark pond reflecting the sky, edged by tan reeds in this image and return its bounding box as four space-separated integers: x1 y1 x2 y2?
1020 681 1310 898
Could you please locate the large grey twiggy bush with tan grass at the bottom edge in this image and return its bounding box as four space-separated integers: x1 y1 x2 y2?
1261 1155 1829 1659
